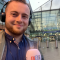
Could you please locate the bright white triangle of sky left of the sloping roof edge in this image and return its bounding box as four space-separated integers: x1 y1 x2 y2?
30 0 48 11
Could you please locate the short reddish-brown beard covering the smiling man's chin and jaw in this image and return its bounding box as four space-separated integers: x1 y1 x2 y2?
6 26 26 36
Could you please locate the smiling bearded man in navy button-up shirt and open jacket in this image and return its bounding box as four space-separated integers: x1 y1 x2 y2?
0 0 44 60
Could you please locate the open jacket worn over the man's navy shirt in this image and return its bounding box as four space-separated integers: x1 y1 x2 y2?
0 30 44 60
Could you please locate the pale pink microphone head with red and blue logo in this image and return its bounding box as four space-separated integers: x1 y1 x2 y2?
26 49 41 60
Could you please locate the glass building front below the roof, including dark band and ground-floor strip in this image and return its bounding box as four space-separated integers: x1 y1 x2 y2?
30 9 60 41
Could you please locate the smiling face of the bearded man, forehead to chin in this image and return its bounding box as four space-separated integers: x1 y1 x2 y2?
5 1 30 35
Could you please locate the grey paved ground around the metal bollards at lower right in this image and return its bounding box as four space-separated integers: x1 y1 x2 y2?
40 41 60 60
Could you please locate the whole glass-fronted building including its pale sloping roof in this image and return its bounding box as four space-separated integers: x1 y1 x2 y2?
30 0 60 40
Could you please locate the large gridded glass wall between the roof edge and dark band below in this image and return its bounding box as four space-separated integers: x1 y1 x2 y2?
32 10 60 31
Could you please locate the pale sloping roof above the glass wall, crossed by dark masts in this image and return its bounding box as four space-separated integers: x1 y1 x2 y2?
34 0 60 12
